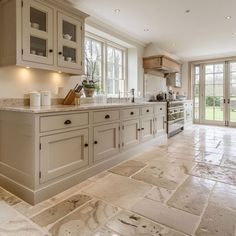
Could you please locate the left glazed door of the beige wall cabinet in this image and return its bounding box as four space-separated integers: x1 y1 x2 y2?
22 0 54 65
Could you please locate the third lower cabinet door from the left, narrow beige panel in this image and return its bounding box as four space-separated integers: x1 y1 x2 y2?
123 119 140 149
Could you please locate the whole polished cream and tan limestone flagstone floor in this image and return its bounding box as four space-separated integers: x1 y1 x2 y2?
0 125 236 236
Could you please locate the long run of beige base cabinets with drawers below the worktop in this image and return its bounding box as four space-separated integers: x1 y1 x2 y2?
0 104 167 204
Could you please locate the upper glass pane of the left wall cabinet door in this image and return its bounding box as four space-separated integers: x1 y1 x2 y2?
30 7 47 32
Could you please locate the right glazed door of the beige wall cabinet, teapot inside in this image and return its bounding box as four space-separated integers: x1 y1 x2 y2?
58 12 83 70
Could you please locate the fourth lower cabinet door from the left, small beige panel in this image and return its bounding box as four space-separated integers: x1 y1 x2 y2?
141 116 154 142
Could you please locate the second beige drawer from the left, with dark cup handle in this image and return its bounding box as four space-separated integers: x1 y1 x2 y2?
93 110 120 124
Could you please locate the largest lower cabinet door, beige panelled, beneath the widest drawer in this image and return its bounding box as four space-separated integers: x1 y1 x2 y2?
40 129 89 183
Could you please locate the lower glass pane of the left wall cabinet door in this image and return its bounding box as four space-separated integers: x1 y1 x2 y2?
30 36 47 57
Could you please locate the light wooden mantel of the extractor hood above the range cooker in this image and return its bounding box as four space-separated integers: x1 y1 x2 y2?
143 55 181 74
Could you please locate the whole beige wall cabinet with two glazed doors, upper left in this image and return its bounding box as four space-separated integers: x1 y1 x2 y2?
0 0 88 74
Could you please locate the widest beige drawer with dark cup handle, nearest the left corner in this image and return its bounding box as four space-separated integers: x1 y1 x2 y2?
40 113 89 132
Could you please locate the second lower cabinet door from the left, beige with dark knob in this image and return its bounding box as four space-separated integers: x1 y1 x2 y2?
93 123 120 162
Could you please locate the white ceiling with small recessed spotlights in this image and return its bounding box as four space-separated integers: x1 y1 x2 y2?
66 0 236 60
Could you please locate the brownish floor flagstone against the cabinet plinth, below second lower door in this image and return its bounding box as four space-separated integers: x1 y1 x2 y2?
109 160 146 177
